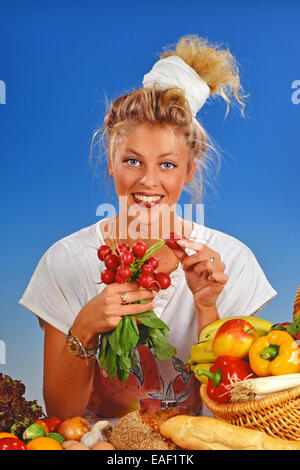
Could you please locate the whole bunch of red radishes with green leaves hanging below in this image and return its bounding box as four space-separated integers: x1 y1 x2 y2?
98 240 176 382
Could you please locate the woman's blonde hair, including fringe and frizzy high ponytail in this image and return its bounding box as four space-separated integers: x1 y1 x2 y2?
91 35 245 202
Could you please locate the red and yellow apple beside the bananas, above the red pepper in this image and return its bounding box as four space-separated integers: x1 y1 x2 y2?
212 318 259 359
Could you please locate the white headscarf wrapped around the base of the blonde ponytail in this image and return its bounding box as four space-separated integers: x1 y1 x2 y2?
143 55 210 116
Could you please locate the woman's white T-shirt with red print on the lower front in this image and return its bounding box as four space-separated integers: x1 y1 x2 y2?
19 218 276 416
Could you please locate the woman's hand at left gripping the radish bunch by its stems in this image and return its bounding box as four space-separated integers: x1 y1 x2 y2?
71 281 156 349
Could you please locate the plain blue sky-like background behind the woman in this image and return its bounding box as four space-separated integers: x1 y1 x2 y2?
0 0 300 410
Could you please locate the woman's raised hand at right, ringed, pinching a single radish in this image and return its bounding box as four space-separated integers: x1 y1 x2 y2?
173 240 228 310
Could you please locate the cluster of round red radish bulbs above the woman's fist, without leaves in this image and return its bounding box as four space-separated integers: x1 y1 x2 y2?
98 237 183 290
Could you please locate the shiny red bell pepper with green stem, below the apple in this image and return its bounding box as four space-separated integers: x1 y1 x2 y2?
197 356 255 403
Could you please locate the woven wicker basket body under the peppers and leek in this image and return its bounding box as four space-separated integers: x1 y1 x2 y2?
200 384 300 440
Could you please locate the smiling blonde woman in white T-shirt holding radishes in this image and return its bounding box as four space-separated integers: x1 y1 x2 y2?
19 36 276 418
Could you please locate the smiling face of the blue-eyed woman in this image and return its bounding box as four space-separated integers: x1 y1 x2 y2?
109 124 195 233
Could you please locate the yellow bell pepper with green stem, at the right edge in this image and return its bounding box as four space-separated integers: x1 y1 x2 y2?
249 330 300 377
